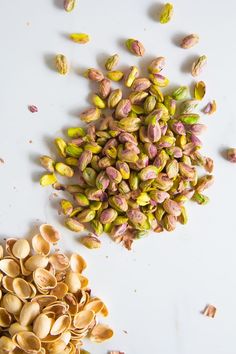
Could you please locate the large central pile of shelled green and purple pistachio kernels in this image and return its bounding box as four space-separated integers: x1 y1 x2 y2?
40 50 213 249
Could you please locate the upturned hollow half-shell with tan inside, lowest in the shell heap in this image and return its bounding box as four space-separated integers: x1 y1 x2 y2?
12 332 41 354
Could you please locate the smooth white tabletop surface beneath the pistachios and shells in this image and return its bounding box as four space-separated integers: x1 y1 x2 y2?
0 0 236 354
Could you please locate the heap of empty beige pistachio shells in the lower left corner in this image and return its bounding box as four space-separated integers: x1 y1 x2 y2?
0 224 113 354
